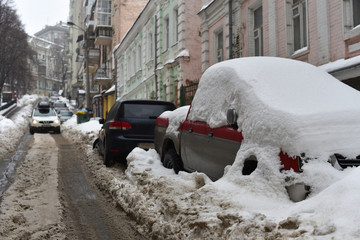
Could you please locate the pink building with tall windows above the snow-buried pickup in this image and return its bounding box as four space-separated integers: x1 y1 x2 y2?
199 0 360 90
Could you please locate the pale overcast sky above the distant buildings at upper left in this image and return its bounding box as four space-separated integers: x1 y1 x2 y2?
14 0 69 35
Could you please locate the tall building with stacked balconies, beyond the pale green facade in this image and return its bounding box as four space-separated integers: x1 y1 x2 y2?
70 0 147 111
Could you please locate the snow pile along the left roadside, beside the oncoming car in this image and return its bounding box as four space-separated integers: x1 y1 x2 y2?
0 95 39 155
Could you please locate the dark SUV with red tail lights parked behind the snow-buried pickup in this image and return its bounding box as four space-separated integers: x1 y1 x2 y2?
94 100 175 166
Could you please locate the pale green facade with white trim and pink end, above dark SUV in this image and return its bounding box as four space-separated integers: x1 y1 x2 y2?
114 0 201 105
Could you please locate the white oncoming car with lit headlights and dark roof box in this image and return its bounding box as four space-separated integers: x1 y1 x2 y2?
30 102 60 134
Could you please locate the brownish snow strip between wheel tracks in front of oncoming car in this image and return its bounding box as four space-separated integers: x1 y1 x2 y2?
0 134 66 240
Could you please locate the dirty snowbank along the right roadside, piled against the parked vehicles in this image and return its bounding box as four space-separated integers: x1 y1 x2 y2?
63 110 360 239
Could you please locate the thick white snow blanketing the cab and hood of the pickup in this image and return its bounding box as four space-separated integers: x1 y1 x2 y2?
189 57 360 156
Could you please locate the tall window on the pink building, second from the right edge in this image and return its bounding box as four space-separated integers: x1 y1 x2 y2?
292 0 307 51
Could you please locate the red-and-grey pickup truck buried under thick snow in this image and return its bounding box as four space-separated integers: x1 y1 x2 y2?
155 57 360 202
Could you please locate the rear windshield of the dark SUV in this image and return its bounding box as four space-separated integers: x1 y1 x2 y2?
123 104 173 119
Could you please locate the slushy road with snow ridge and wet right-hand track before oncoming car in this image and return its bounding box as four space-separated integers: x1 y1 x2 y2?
0 134 145 240
